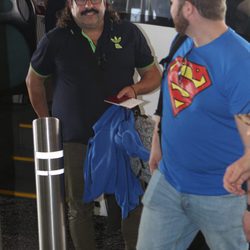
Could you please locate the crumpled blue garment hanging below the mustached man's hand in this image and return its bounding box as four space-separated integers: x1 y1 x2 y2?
84 105 149 218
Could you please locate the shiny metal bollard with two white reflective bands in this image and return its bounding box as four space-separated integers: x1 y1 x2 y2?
33 117 66 250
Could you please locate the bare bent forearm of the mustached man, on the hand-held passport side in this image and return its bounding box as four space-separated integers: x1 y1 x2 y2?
133 65 161 95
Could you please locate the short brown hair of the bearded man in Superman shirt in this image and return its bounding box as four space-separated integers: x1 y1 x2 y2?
180 0 227 20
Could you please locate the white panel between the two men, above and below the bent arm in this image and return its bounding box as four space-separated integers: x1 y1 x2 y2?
137 24 176 115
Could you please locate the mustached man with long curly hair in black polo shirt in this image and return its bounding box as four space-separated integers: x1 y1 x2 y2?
27 0 160 250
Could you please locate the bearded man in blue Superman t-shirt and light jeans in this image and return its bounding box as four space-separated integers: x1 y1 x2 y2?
137 0 250 250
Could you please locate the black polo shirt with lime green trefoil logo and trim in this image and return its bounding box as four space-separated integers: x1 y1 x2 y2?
31 14 154 144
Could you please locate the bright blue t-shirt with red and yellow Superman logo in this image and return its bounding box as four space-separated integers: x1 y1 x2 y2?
160 28 250 195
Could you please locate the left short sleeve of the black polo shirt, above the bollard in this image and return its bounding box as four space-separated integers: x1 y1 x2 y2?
31 34 55 76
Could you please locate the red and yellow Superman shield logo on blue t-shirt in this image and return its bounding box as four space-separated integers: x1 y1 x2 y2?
168 57 211 116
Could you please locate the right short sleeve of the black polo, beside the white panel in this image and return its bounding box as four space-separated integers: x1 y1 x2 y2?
134 25 154 68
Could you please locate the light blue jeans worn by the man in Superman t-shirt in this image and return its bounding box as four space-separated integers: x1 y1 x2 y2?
137 170 248 250
